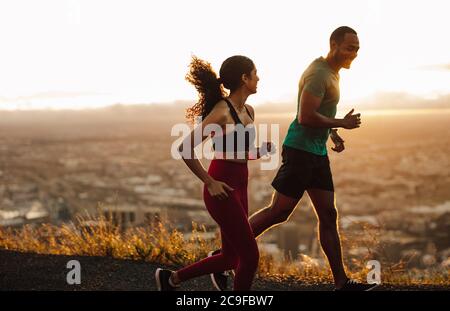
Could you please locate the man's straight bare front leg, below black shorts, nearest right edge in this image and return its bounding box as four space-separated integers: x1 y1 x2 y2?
307 189 348 288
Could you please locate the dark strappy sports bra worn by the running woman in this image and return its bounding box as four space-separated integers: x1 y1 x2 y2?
211 98 256 153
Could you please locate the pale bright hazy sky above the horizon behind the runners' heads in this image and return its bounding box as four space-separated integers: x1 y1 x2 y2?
0 0 450 109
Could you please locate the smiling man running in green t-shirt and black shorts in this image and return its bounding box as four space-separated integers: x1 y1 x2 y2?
211 26 376 291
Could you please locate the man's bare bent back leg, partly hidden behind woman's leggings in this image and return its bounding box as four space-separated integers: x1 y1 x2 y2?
249 190 300 237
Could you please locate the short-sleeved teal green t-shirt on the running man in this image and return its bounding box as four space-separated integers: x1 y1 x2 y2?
283 57 339 155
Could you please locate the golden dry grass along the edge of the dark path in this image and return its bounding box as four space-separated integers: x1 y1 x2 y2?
0 216 450 285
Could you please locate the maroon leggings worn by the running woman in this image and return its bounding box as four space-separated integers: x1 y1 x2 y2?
178 159 259 290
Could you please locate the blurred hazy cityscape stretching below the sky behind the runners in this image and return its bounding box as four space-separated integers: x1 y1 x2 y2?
0 106 450 268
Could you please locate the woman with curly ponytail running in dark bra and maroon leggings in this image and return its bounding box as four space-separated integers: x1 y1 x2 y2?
155 55 274 290
